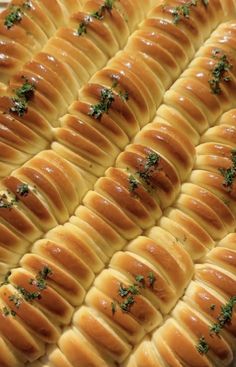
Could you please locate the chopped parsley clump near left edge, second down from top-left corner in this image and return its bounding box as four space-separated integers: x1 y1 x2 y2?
10 76 35 117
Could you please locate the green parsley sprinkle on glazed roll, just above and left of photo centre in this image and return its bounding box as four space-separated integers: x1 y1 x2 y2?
88 80 128 119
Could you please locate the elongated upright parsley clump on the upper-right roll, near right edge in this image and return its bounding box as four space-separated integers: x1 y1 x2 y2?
208 49 232 94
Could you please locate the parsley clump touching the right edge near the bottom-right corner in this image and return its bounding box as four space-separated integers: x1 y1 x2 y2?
210 296 236 335
